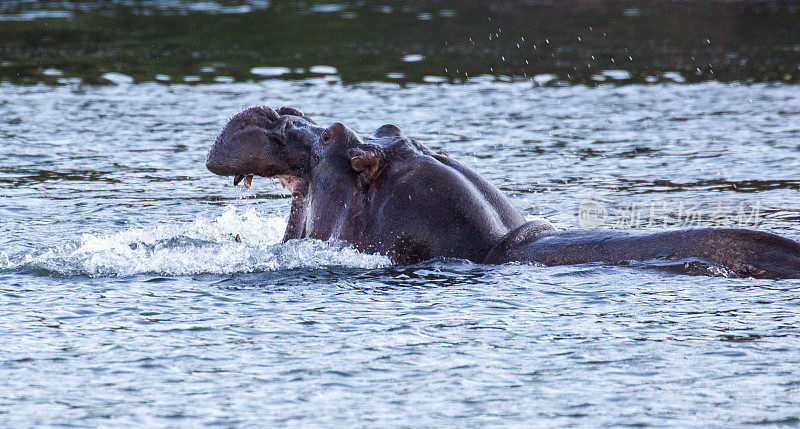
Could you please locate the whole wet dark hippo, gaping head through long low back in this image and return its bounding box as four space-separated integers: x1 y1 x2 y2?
206 107 800 278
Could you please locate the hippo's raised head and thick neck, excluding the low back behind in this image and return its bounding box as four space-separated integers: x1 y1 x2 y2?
206 107 525 264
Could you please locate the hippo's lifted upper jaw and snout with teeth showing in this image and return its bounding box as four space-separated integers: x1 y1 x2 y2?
206 106 323 188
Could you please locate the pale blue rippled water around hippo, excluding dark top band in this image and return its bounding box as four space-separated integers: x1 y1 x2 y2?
0 77 800 427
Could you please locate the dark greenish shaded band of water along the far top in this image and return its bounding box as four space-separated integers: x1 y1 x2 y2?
0 0 800 85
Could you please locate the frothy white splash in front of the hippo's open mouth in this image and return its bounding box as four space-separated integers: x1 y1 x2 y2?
5 207 390 277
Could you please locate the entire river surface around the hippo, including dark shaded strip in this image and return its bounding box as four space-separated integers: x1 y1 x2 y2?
0 1 800 427
